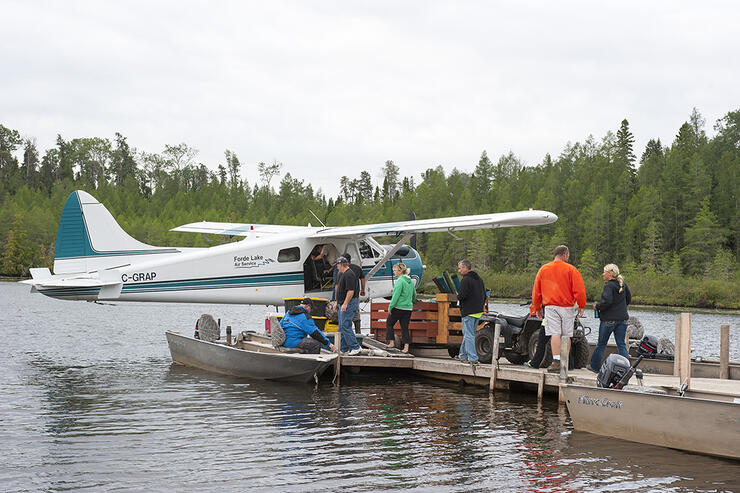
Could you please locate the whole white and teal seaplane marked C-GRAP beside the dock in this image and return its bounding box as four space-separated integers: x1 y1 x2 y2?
23 190 557 305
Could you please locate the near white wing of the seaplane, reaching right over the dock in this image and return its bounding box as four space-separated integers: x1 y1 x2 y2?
312 210 558 238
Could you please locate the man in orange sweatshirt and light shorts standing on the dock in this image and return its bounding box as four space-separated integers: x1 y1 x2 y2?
530 245 586 373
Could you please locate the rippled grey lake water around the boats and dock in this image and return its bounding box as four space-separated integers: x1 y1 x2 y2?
0 283 740 492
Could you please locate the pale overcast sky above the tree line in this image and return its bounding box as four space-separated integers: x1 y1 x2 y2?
0 0 740 195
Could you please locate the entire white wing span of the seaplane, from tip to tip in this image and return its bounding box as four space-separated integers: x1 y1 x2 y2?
170 210 558 238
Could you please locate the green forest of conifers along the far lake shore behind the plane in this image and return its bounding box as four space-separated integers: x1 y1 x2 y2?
0 109 740 307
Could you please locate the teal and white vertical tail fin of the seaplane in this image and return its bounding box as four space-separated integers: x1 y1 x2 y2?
54 190 178 274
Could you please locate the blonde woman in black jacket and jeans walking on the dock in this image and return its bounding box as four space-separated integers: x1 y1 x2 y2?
587 264 632 373
